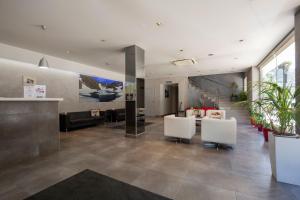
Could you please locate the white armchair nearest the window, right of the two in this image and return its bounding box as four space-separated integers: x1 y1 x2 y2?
201 117 237 145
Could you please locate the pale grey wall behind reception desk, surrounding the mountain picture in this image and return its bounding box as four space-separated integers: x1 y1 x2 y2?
0 44 125 112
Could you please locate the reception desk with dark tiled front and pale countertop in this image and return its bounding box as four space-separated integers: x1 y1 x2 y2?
0 98 63 168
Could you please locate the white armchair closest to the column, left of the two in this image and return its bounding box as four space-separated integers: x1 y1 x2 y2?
164 115 196 140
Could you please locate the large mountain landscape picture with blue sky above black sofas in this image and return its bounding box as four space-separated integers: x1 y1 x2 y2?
79 74 123 102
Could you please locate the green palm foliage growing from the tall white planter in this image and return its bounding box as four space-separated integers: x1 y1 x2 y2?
254 82 300 135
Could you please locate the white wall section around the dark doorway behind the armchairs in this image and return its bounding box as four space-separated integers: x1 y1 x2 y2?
145 77 188 116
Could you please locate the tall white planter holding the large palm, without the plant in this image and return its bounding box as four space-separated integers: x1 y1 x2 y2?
269 132 300 185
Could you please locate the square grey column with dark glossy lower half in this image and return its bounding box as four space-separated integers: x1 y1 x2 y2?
125 45 145 137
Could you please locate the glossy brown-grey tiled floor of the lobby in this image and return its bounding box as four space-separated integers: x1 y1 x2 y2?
0 118 300 200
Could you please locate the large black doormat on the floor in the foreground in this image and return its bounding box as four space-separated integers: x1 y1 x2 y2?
25 169 170 200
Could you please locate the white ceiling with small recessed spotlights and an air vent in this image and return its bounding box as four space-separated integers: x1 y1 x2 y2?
0 0 300 77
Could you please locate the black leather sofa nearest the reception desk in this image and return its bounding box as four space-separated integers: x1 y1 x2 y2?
59 111 104 131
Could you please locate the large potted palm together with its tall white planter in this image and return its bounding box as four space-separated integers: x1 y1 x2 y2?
256 82 300 185
